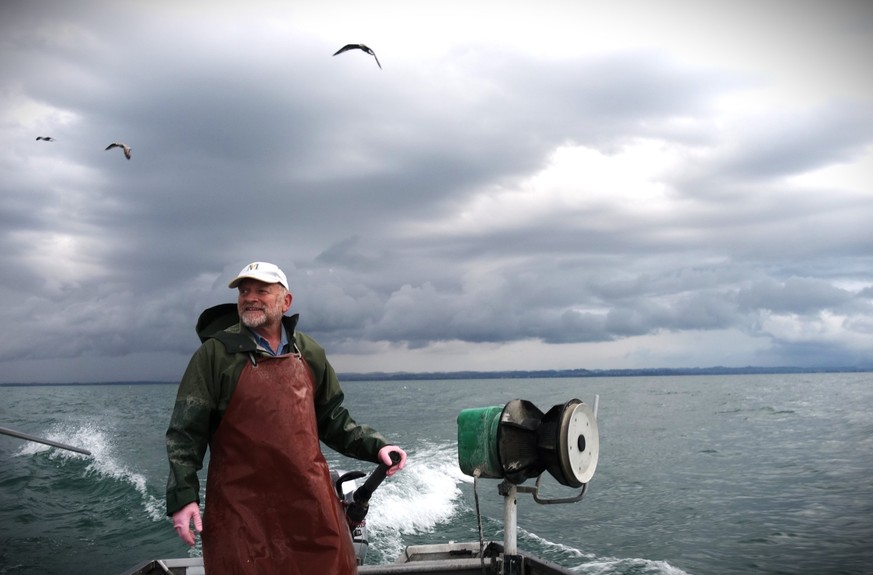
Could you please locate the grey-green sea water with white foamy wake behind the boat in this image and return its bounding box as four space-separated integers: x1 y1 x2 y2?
0 373 873 575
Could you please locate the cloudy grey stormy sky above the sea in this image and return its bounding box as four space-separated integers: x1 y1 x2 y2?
0 0 873 382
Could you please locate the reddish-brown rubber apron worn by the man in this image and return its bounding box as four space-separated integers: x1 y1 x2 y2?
202 355 357 575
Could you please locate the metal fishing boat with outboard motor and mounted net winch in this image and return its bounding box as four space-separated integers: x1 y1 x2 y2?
122 397 600 575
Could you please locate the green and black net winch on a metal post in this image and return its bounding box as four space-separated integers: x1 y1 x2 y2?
458 396 600 574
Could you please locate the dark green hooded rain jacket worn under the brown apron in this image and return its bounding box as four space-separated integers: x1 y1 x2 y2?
166 304 388 515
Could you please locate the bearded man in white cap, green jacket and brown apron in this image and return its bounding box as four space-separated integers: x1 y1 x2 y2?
167 262 406 575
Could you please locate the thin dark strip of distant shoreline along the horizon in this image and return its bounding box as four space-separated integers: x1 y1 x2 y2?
0 366 873 387
